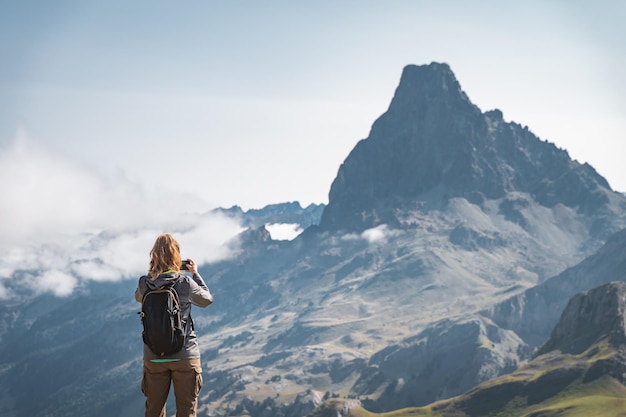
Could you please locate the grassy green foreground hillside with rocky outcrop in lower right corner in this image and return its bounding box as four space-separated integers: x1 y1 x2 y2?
309 282 626 417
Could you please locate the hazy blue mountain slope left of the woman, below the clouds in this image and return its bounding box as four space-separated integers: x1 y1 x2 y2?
0 282 143 417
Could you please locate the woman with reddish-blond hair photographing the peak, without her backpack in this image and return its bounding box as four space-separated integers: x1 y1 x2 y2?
135 234 213 417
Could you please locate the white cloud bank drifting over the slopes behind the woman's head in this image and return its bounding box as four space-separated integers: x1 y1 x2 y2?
0 132 242 298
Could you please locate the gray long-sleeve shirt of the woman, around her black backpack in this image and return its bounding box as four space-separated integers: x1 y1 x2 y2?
135 272 213 360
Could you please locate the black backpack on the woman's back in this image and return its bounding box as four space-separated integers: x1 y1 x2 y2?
137 283 186 357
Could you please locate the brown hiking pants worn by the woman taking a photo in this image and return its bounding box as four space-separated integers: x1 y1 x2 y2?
141 359 202 417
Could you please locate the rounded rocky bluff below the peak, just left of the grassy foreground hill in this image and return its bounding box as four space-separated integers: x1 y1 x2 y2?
352 317 532 411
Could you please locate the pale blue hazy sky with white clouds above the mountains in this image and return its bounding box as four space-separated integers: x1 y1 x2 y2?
0 0 626 295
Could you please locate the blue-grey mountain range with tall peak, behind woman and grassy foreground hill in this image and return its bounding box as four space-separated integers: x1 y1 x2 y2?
0 63 626 417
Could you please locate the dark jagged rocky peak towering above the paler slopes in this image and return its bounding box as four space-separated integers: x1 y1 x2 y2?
321 63 615 234
